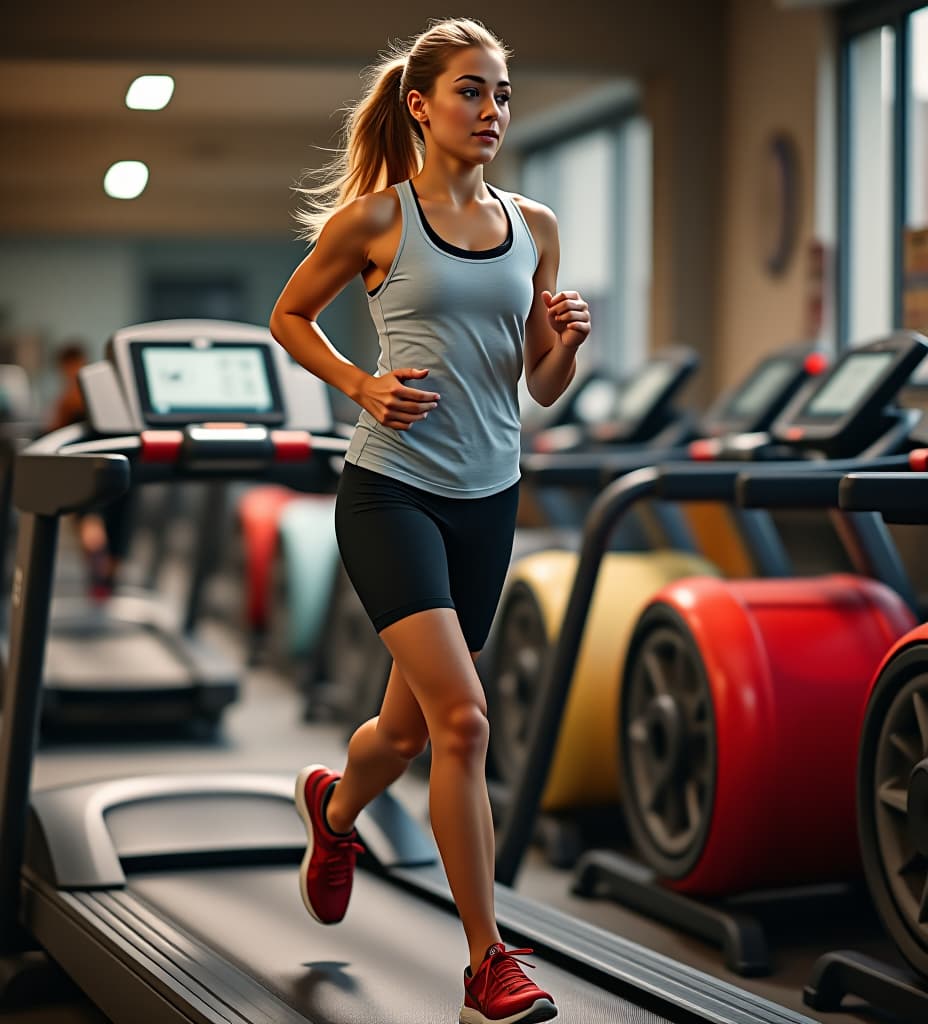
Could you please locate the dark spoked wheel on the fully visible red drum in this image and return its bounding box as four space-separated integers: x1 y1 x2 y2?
621 605 716 878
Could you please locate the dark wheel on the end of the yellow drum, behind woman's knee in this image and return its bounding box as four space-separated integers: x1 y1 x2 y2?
487 581 550 783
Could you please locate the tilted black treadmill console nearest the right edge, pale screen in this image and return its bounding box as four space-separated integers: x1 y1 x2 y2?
771 331 928 452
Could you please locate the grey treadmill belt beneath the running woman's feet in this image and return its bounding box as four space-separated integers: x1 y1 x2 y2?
130 866 670 1024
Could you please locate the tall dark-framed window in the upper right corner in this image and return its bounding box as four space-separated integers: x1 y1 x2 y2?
839 0 928 352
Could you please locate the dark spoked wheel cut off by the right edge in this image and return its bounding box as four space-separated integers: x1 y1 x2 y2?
857 642 928 976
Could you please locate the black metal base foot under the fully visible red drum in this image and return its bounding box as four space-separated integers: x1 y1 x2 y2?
573 850 770 977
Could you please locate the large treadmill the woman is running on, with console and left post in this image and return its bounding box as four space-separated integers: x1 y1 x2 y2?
0 326 811 1024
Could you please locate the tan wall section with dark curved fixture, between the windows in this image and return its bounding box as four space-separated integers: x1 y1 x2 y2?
713 0 834 389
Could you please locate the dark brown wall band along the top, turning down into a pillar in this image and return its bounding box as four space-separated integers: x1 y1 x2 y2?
0 0 724 385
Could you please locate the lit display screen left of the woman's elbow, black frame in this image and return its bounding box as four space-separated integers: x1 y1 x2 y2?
132 341 284 423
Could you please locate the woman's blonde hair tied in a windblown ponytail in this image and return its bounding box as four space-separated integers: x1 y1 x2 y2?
295 17 511 242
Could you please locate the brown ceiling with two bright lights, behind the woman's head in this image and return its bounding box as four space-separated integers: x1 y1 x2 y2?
0 56 616 238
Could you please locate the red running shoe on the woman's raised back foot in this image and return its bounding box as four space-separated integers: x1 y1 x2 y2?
295 765 364 925
